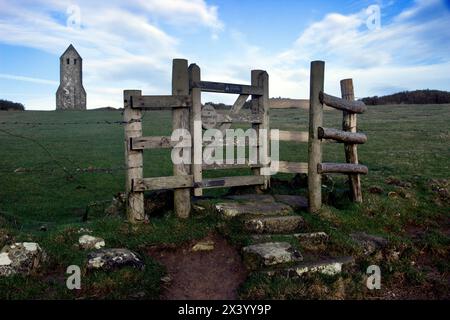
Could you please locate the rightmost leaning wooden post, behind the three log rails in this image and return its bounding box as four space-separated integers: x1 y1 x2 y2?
341 79 362 202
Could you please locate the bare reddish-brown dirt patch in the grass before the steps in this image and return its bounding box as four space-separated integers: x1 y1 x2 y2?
149 234 247 300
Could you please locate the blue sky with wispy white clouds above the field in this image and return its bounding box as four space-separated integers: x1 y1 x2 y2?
0 0 450 110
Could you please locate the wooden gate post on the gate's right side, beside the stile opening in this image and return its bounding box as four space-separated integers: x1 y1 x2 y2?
251 70 270 190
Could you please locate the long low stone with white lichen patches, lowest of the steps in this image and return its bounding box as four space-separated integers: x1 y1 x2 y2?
261 257 355 278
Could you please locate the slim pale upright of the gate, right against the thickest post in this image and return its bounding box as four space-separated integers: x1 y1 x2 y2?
189 64 203 197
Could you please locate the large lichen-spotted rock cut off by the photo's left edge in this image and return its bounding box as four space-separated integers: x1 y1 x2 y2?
0 242 46 276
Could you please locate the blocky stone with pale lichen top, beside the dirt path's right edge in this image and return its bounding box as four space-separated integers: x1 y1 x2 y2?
242 242 303 270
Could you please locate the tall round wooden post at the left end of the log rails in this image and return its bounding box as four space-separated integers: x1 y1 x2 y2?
308 61 325 212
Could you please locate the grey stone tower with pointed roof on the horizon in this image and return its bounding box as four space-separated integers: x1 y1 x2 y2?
56 45 86 110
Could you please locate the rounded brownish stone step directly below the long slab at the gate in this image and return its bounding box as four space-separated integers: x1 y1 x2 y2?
244 216 304 233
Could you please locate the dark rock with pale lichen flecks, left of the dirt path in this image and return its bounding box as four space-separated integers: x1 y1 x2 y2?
87 248 144 271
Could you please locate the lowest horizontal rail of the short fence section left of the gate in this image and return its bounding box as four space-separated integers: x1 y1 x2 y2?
133 175 194 191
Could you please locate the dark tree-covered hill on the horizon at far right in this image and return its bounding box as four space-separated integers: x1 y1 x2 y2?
361 90 450 105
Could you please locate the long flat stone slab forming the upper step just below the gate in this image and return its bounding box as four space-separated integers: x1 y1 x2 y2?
215 201 293 219
